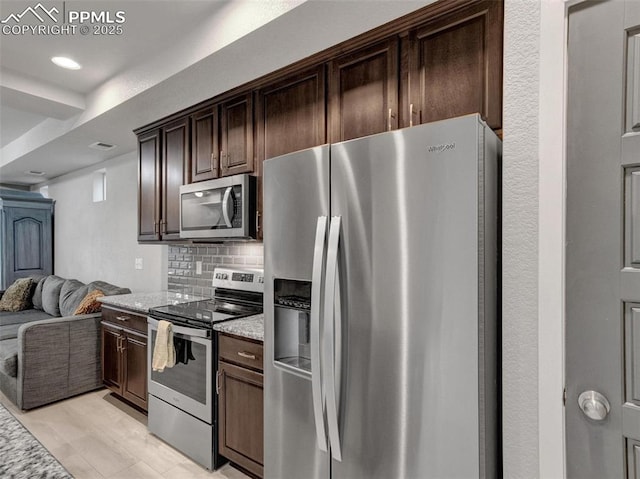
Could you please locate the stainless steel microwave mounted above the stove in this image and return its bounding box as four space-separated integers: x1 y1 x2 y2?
180 175 256 239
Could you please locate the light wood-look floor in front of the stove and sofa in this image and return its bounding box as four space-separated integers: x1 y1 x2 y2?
0 389 248 479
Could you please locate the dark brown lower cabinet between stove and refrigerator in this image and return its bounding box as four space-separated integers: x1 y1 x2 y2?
217 336 264 477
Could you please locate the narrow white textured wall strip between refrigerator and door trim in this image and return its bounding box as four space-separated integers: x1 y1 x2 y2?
502 0 540 479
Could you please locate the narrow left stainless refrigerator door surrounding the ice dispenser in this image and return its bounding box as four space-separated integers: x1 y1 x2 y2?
264 146 330 479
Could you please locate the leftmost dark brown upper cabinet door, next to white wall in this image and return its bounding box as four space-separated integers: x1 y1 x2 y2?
138 130 160 241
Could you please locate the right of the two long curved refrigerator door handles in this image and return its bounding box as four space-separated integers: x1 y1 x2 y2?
323 216 342 461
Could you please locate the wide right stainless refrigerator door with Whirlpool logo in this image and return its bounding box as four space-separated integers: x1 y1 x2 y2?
330 115 496 479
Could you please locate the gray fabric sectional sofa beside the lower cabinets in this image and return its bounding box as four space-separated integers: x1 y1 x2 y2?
0 275 131 409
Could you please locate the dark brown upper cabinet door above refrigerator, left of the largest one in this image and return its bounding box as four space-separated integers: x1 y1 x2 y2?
329 37 399 143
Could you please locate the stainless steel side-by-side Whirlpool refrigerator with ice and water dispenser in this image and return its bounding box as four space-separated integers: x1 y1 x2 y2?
264 115 501 479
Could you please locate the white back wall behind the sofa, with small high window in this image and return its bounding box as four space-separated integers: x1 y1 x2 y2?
39 152 167 291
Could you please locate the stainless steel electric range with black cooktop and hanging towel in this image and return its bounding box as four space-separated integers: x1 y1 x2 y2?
147 268 263 469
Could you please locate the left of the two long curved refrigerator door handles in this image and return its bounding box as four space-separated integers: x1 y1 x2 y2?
310 216 328 452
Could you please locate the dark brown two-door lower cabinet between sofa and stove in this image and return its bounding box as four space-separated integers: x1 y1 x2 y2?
102 308 147 411
